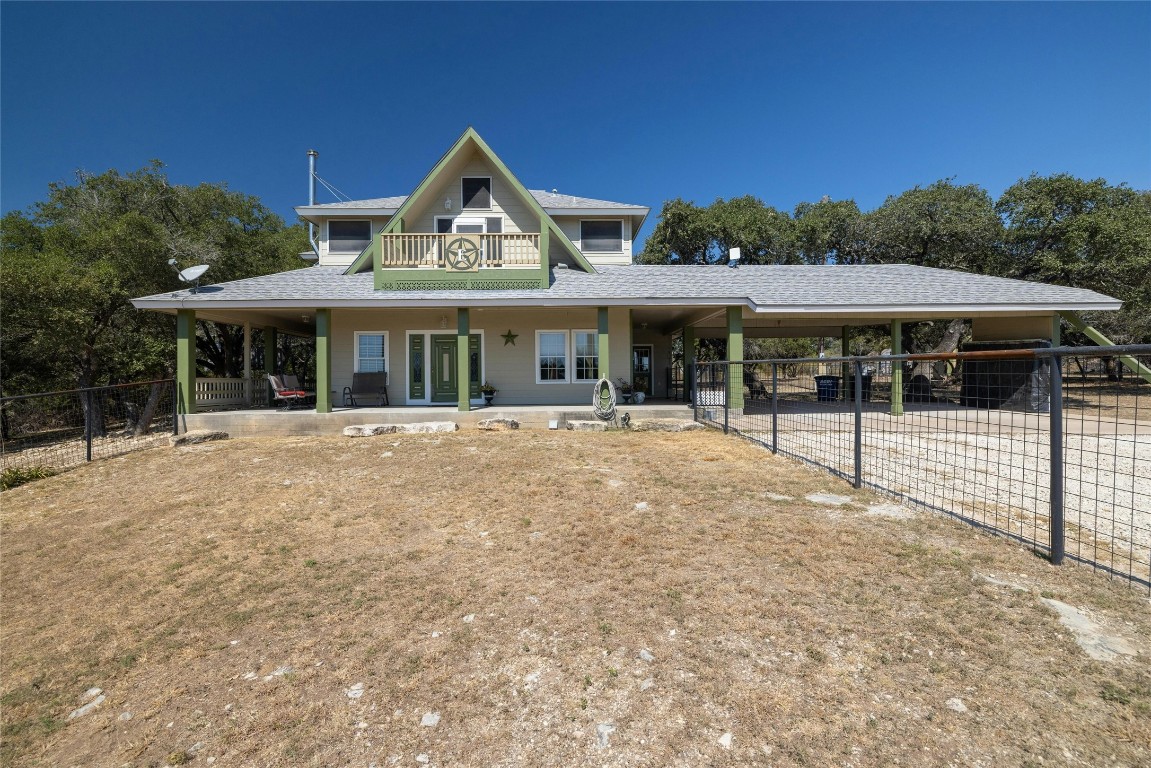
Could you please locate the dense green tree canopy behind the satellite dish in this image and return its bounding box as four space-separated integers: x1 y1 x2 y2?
0 162 306 394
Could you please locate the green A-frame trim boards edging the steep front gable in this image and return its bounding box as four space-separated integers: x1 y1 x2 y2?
356 126 595 284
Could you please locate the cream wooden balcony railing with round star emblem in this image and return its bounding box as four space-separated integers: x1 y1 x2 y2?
379 233 540 272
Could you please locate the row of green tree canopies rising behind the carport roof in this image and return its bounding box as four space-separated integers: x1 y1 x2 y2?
638 174 1151 348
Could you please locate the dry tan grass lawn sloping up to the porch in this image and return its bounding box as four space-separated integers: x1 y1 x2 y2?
0 432 1151 768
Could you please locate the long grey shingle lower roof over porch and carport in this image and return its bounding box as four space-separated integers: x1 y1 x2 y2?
136 265 1119 313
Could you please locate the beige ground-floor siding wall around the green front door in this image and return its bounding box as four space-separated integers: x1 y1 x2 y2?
331 307 639 406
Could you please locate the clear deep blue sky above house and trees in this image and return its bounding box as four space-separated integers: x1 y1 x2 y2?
0 1 1151 252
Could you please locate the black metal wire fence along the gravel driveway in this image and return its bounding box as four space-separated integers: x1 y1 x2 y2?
692 345 1151 592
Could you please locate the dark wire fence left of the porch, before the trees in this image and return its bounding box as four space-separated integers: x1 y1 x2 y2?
0 379 176 472
